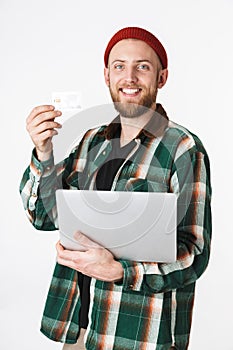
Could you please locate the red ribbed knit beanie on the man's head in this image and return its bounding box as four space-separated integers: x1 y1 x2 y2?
104 27 167 69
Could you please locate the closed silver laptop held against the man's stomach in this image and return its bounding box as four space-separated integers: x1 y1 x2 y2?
56 190 177 262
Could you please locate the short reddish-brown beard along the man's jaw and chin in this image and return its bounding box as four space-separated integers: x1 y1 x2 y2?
109 86 157 118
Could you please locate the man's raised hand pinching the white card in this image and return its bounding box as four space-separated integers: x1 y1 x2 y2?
26 105 62 161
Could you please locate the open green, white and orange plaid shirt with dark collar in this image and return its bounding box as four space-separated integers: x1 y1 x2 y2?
20 105 211 350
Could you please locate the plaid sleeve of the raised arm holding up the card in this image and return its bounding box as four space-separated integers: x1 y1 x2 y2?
20 128 103 231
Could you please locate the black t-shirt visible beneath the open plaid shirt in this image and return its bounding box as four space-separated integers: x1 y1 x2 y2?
78 134 136 328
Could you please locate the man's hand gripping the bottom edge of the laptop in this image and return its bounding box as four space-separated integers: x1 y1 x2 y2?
56 231 123 282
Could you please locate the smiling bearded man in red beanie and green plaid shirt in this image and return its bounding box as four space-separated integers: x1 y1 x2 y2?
20 27 211 350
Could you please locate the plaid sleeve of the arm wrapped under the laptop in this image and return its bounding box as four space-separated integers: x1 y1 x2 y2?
115 141 212 293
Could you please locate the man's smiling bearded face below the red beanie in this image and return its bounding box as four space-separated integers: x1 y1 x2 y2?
105 39 166 118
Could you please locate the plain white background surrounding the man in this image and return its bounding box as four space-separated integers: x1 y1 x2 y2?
0 0 233 350
